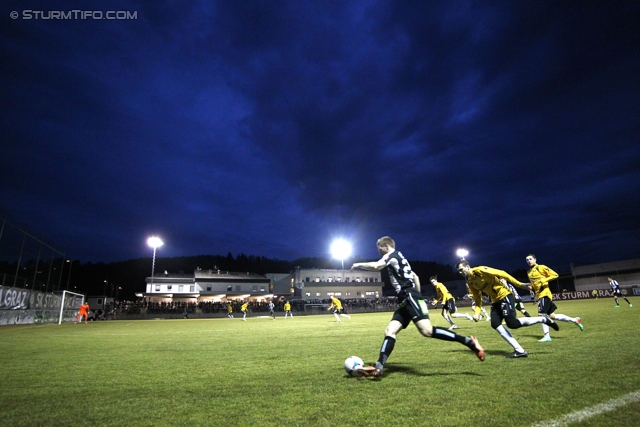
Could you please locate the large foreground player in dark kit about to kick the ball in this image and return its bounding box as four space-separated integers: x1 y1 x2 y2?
351 236 484 377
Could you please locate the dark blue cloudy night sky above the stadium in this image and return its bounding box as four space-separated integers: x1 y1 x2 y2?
0 0 640 271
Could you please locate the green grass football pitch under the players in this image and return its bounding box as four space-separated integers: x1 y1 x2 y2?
0 299 640 427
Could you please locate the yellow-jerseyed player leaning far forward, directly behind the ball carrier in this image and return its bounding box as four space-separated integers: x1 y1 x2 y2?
456 259 560 358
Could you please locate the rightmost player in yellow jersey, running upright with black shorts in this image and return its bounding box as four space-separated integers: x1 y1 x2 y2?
525 254 584 342
